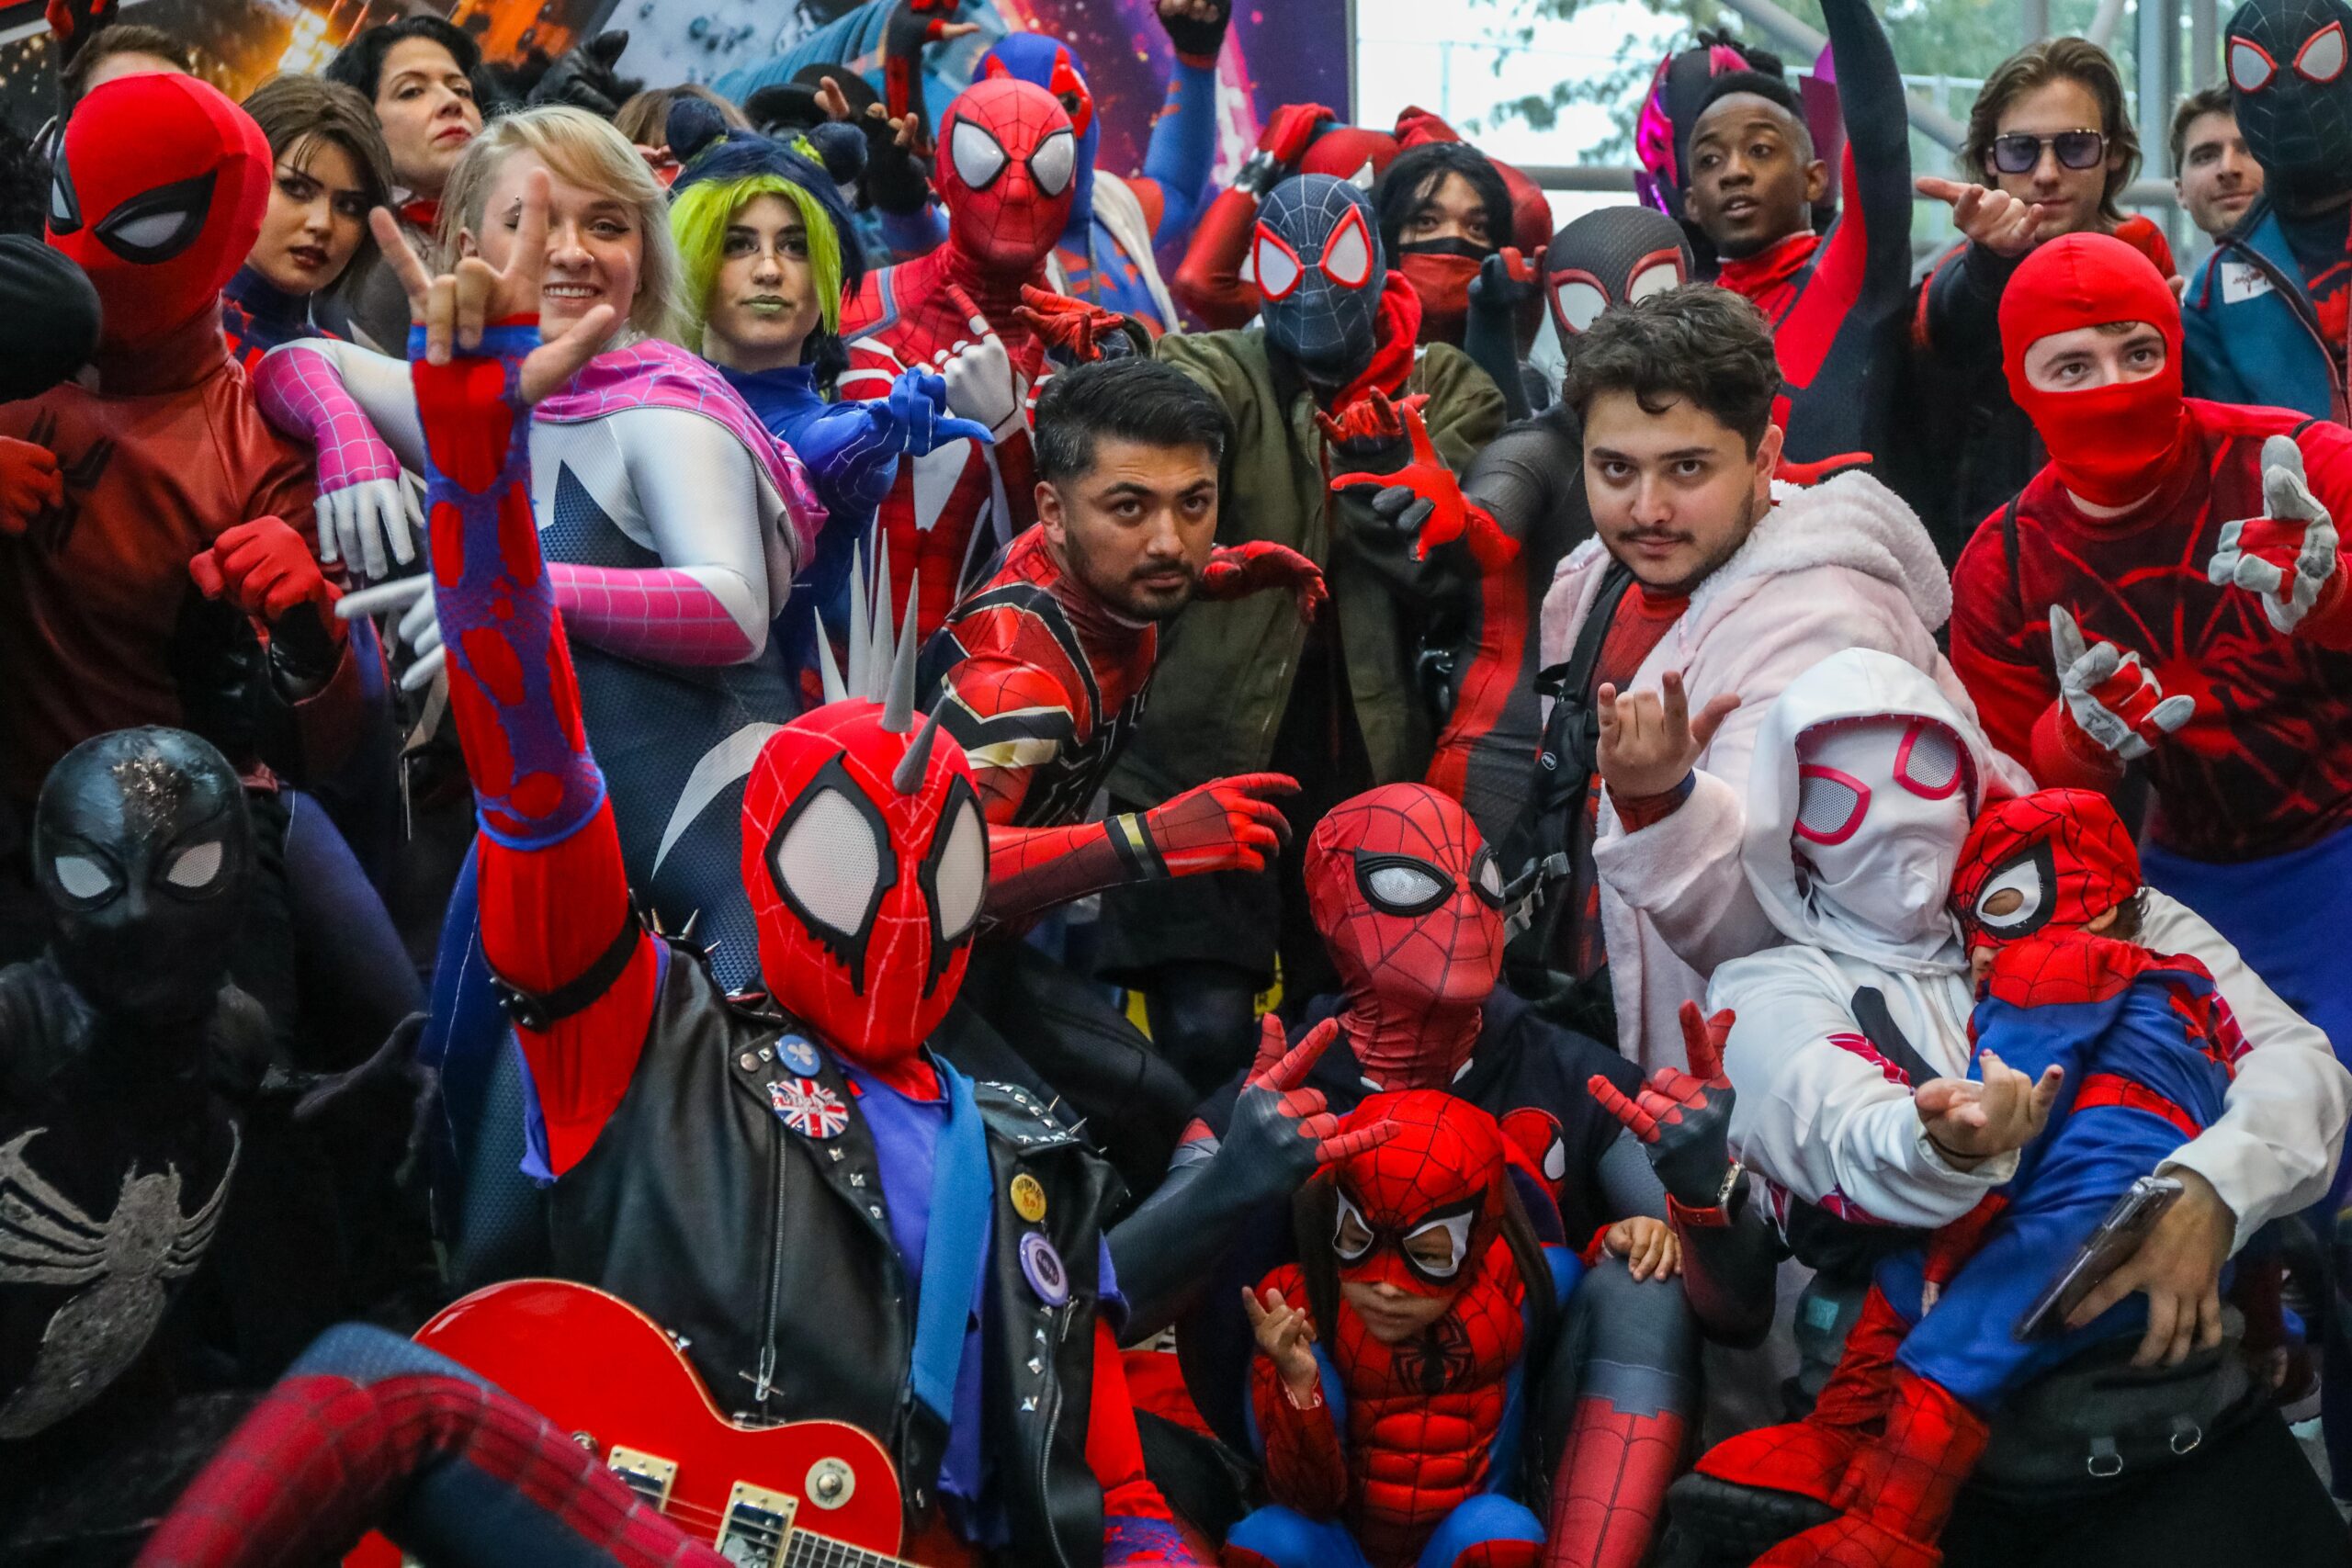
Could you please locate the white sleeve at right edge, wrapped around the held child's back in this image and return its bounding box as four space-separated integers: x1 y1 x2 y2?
2141 888 2352 1246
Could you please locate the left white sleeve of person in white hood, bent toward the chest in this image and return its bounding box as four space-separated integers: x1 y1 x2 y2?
1708 947 2018 1229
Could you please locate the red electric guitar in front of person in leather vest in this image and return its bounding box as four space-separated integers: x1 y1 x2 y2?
344 1279 965 1568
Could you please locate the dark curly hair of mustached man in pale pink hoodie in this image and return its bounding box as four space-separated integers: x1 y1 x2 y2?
1562 282 1781 456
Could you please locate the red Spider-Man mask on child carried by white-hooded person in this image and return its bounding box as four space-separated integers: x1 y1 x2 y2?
1952 790 2141 947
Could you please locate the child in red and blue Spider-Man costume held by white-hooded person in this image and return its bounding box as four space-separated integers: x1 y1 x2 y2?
1740 790 2244 1568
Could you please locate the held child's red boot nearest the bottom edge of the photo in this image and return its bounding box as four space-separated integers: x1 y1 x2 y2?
1755 1371 1985 1568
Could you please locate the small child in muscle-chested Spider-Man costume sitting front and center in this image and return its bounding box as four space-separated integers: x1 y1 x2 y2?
1223 1089 1580 1568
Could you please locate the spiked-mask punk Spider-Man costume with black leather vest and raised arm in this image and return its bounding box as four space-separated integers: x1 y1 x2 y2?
412 322 1193 1563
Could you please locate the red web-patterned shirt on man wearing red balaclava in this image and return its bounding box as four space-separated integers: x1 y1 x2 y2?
1952 398 2352 861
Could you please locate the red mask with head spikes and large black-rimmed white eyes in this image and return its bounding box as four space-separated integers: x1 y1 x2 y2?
743 686 988 1067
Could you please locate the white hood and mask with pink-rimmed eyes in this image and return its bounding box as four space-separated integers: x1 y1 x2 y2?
1740 649 2007 976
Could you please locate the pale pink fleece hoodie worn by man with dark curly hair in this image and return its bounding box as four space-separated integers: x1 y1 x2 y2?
1543 472 2004 1072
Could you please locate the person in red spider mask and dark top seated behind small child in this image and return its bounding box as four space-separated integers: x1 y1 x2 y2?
1114 785 1771 1568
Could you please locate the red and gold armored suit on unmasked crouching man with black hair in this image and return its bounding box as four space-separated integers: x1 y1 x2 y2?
917 526 1322 924
